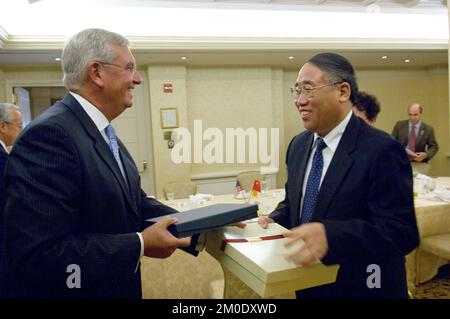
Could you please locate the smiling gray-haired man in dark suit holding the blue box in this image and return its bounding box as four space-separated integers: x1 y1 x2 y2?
0 29 190 298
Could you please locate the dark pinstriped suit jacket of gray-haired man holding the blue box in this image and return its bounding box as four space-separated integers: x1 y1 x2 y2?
3 94 181 298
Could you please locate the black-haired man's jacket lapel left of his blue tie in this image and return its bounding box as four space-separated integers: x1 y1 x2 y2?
291 133 314 225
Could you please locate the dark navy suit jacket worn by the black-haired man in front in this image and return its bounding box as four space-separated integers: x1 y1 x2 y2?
270 115 419 298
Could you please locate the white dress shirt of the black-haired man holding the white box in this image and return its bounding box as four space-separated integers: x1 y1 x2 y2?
300 110 353 216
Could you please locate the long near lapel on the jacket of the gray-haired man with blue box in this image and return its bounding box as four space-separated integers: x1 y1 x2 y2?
61 93 138 218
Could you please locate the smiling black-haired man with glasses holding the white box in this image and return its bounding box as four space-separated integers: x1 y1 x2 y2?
259 53 419 299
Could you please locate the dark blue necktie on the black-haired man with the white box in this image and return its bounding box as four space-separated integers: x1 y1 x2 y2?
300 138 327 225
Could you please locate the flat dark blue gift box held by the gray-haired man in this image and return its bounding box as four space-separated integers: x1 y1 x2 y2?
147 204 258 238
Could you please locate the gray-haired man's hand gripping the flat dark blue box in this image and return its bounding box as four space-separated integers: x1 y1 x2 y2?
142 217 191 258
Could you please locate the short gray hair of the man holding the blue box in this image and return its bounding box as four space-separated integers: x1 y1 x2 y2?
61 29 129 90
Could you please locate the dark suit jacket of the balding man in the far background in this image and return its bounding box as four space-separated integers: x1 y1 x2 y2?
392 120 439 163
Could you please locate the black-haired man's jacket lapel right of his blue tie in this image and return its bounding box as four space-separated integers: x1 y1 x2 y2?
313 115 360 219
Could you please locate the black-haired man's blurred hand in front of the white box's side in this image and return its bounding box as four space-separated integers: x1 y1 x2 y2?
284 223 328 267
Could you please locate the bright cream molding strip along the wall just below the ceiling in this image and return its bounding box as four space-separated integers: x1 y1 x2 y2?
0 35 448 51
